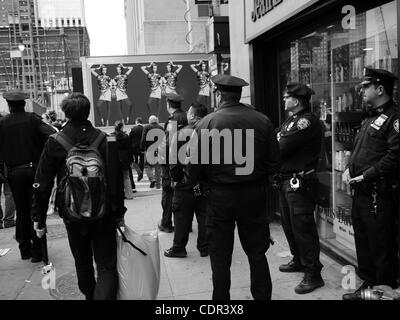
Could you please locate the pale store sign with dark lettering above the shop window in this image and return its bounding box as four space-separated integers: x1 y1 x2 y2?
245 0 318 43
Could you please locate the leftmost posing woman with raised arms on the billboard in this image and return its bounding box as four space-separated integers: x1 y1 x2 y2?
91 65 113 127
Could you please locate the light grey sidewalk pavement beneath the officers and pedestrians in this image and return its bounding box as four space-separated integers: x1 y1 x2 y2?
0 176 359 300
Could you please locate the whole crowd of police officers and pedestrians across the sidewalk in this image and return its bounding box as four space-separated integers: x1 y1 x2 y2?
0 69 399 300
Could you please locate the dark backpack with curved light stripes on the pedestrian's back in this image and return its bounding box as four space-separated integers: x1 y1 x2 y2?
52 132 107 222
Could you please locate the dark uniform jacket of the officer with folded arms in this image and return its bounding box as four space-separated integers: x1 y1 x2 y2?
278 110 323 174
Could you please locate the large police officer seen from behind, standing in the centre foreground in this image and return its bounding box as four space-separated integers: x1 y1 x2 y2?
188 75 279 300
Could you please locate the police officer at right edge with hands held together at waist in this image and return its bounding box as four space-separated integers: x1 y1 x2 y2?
343 68 400 300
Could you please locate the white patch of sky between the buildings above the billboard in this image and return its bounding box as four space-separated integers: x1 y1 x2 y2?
84 0 127 56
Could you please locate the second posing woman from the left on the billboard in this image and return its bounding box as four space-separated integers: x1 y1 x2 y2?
114 64 133 124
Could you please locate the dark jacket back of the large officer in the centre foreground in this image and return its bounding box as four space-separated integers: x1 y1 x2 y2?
188 102 280 185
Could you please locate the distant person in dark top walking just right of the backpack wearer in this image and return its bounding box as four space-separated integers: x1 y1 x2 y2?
111 121 134 200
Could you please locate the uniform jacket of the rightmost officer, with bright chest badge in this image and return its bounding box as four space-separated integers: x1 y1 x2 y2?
349 101 400 181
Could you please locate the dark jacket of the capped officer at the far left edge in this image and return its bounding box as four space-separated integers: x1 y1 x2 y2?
0 111 55 167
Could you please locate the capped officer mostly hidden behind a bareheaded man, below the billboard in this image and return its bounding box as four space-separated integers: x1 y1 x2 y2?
158 93 188 233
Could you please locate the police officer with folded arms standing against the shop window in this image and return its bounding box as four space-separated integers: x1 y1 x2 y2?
278 83 324 294
